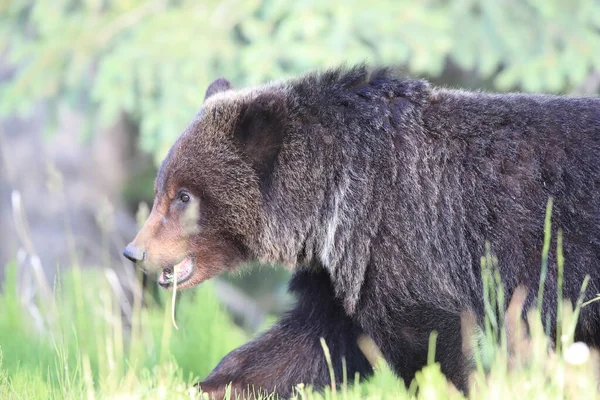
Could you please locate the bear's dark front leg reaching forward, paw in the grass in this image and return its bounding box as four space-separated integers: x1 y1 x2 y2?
199 270 373 399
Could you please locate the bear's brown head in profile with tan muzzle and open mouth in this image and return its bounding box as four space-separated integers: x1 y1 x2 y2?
123 79 288 288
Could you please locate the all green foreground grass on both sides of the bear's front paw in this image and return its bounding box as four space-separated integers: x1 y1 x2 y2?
0 205 600 400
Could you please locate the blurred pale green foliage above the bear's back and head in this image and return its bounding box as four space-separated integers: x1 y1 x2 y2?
0 0 600 160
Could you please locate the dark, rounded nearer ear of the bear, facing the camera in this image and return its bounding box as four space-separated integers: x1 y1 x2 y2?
234 92 287 183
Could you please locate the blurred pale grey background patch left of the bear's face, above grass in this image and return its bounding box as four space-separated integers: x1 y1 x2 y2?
0 57 136 292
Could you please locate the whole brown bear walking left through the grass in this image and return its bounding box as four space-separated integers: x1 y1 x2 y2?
124 65 600 397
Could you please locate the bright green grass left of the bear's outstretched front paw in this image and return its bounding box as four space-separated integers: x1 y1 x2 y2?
0 265 247 399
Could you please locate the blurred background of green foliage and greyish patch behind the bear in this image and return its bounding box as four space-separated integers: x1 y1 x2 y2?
0 0 600 332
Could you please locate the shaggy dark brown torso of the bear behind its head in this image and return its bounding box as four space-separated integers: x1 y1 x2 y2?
250 68 600 314
